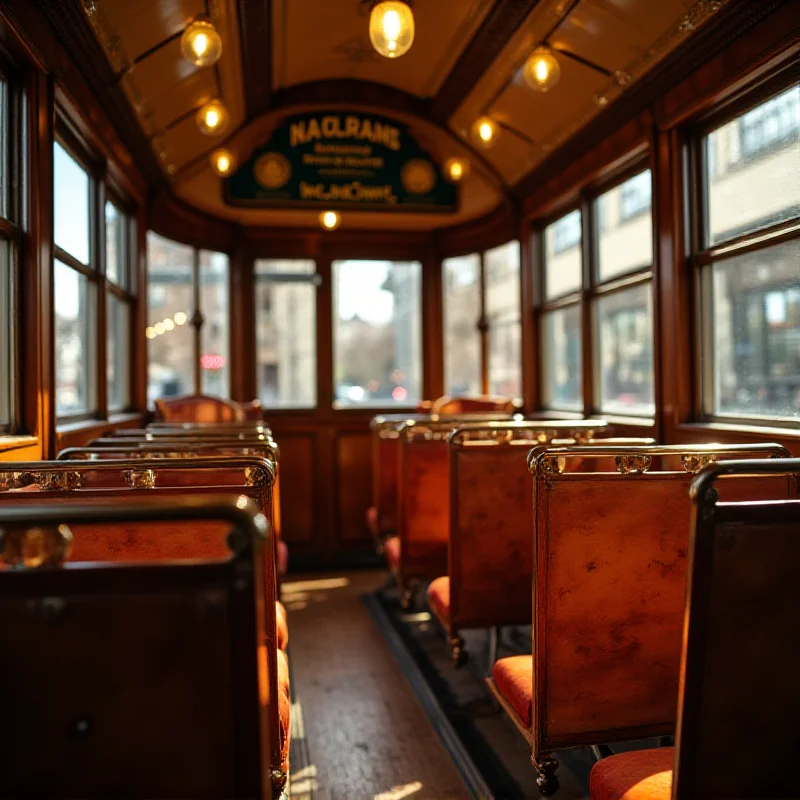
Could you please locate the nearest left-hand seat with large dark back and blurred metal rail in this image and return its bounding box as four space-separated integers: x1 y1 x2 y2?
0 492 289 798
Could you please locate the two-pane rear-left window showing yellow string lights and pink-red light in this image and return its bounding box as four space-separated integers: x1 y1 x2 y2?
145 231 230 405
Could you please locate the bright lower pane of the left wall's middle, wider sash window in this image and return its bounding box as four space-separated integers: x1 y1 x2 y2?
54 261 94 416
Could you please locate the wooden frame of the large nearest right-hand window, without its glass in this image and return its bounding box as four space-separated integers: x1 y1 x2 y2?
683 77 800 429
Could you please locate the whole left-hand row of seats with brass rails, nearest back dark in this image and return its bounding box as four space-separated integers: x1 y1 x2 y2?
0 398 291 798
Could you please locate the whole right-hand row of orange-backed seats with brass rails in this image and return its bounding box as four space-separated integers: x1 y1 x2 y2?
370 404 800 800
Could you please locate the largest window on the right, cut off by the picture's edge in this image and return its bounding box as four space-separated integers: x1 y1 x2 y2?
693 86 800 423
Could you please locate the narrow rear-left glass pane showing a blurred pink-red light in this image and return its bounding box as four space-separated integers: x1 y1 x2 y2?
200 250 231 397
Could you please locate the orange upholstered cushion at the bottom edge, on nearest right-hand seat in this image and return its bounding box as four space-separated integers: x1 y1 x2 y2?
589 747 675 800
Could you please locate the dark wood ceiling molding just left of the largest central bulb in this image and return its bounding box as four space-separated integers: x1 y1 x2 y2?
236 0 272 120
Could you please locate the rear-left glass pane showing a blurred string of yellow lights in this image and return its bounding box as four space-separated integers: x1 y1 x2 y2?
146 233 197 405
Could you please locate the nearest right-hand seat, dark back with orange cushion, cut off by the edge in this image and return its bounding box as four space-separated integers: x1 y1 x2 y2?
590 459 800 800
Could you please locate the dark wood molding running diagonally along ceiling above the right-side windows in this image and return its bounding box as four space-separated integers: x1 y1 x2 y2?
511 0 797 199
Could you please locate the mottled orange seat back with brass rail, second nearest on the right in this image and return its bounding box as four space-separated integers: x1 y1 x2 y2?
529 444 792 763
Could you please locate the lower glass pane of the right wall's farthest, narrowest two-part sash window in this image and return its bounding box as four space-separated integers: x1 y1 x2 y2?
542 303 583 411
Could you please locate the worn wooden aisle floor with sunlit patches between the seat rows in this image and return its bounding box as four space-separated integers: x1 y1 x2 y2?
283 571 469 800
